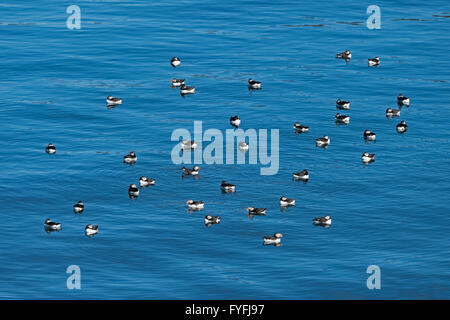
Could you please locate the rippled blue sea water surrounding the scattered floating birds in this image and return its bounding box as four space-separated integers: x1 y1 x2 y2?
0 0 450 299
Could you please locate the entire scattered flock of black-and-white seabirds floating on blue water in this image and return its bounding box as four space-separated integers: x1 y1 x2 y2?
44 49 410 246
